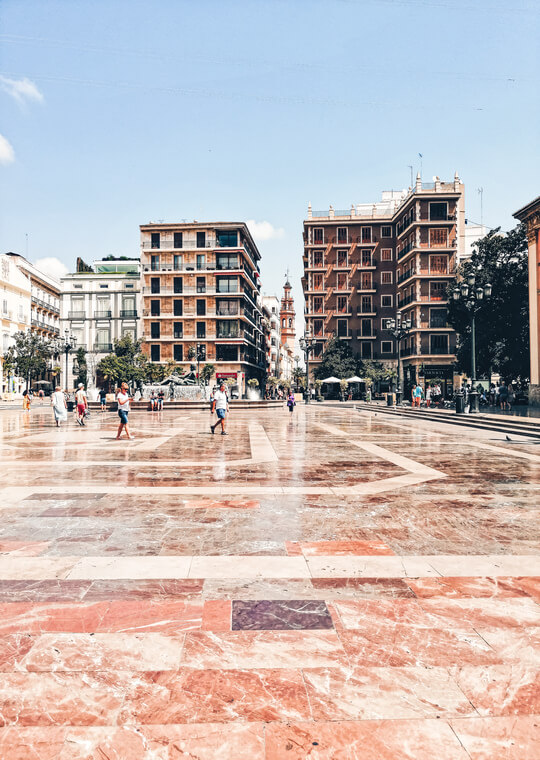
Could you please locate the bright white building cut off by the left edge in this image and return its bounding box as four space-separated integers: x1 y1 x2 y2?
0 253 32 398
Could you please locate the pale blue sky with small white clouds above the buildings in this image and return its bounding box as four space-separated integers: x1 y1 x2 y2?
0 0 540 311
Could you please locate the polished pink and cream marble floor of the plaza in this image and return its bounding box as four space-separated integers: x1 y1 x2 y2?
0 404 540 760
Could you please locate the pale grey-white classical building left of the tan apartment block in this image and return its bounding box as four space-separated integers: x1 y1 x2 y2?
60 258 141 389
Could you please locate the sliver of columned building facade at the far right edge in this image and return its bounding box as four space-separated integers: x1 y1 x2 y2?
514 196 540 406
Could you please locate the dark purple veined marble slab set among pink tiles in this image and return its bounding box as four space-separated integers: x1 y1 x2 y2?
232 599 333 631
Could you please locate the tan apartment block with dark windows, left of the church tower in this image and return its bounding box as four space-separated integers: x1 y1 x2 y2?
140 222 266 393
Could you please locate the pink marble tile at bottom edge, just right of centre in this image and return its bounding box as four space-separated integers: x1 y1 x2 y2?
266 719 469 760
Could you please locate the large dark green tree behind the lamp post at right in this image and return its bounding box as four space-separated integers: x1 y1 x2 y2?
448 224 530 380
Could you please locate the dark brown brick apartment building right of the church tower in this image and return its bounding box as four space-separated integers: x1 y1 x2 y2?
302 174 465 393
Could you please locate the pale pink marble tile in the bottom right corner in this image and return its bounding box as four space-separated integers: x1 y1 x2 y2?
450 715 540 760
